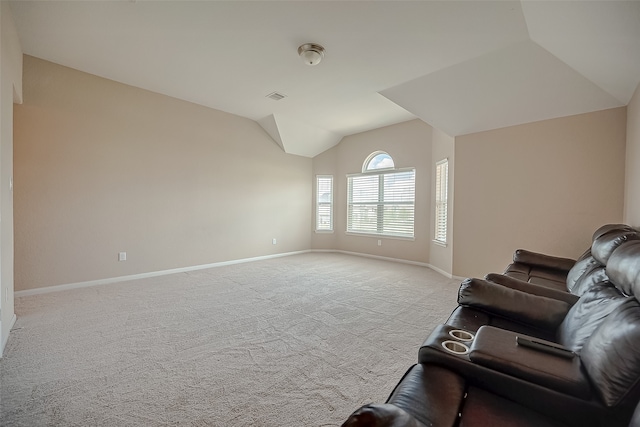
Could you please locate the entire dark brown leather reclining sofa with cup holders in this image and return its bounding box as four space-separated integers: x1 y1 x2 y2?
343 224 640 427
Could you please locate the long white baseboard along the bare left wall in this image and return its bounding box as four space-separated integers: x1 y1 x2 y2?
13 250 311 298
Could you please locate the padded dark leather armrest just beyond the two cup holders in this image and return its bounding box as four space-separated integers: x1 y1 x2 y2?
458 279 570 331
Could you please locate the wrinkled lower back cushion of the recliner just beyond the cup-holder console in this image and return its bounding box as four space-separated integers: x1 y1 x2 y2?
557 281 626 353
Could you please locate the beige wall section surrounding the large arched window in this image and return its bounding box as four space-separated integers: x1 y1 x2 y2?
312 120 432 263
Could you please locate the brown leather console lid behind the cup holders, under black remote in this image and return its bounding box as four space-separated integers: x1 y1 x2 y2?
469 326 591 400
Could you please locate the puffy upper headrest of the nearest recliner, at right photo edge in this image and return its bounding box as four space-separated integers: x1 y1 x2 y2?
606 240 640 297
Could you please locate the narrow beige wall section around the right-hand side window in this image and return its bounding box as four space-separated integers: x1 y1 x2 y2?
429 128 455 275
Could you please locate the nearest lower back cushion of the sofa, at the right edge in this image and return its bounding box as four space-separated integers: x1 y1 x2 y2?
580 298 640 407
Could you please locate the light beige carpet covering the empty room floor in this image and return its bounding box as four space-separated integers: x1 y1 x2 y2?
0 253 459 427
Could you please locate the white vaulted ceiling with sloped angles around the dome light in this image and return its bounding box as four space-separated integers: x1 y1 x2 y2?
11 0 640 157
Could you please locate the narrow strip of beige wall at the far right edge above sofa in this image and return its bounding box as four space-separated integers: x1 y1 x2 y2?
624 81 640 228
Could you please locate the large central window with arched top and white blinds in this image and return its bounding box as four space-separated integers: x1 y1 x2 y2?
347 152 416 238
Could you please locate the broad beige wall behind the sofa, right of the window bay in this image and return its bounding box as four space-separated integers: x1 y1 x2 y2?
453 107 626 276
